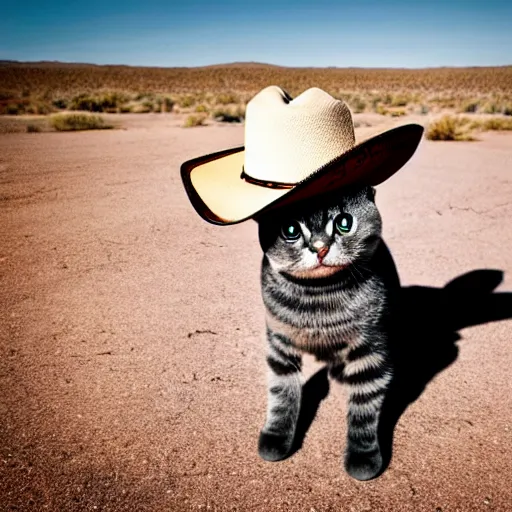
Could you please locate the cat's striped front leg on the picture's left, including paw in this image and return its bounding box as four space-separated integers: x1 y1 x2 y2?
258 329 303 461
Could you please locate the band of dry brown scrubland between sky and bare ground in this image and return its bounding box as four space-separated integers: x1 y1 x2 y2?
0 63 512 121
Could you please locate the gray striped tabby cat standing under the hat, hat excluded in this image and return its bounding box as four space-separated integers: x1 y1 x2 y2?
258 187 400 480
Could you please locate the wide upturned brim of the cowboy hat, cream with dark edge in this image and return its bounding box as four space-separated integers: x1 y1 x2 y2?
181 124 423 225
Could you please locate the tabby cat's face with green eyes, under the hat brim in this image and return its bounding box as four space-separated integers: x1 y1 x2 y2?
258 187 382 279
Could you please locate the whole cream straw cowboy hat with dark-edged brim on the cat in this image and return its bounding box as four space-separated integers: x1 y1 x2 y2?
181 86 423 225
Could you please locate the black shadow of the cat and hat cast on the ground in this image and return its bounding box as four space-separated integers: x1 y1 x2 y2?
289 269 512 471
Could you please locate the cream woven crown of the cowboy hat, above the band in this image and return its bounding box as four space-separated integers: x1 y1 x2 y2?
244 86 355 183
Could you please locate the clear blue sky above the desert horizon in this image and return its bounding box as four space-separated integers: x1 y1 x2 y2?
0 0 512 67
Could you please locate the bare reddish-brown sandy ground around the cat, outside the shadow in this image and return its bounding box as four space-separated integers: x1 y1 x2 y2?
0 114 512 512
